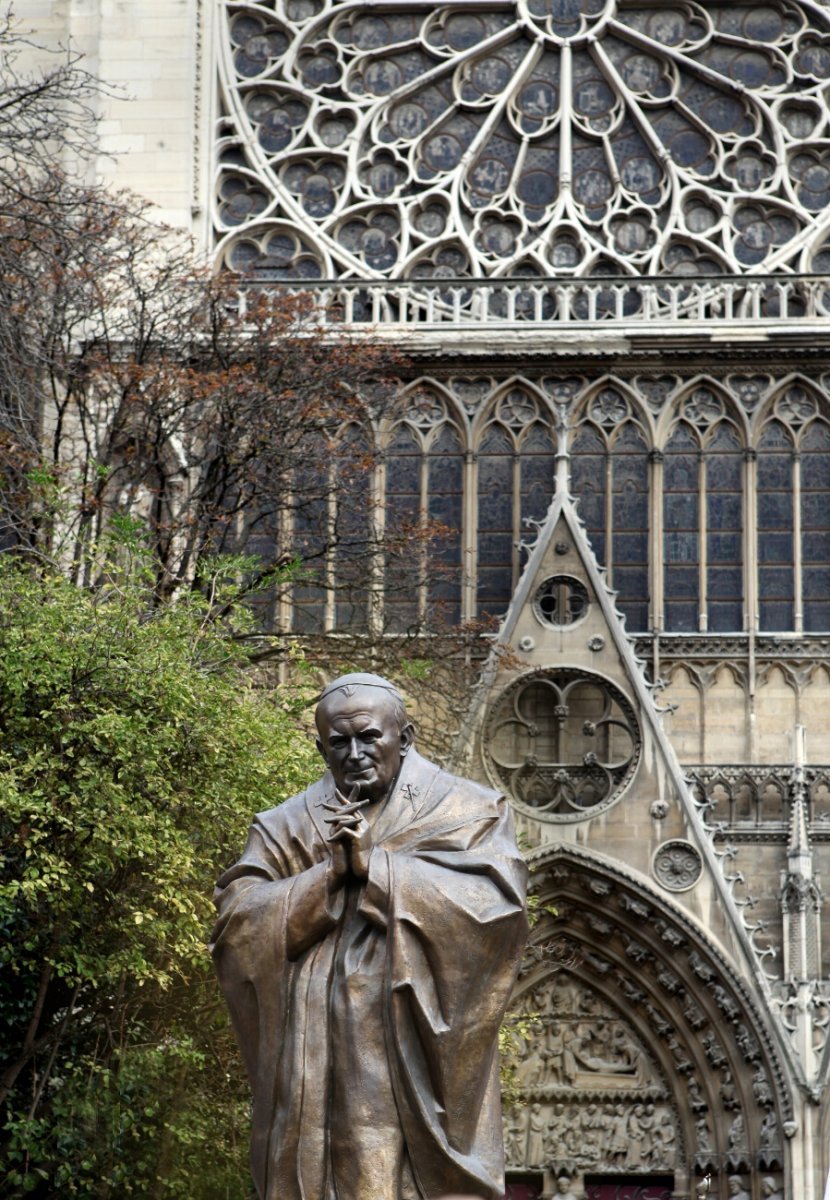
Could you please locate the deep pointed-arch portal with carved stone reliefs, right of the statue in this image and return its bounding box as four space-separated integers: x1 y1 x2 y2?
505 847 792 1200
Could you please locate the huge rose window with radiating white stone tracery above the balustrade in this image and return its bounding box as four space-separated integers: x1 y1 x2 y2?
215 0 830 280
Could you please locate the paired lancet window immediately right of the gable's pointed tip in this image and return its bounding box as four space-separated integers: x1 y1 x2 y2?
571 412 649 631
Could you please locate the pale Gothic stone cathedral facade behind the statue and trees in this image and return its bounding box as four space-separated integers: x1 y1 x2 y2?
25 0 830 1200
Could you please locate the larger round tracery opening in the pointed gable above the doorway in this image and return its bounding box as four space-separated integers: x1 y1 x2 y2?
483 667 640 822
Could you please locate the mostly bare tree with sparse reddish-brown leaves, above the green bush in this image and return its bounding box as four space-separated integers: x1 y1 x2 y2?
0 4 422 620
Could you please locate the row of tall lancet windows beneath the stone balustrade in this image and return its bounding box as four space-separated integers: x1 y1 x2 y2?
273 377 830 634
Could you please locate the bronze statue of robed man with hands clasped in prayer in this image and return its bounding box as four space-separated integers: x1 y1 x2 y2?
212 674 527 1200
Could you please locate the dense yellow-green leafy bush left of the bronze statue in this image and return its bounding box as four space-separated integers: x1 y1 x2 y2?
0 556 317 1200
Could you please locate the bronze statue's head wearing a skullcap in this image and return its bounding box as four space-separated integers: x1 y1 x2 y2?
315 673 414 802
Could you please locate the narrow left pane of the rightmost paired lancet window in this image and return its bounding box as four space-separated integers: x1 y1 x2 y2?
758 420 795 631
